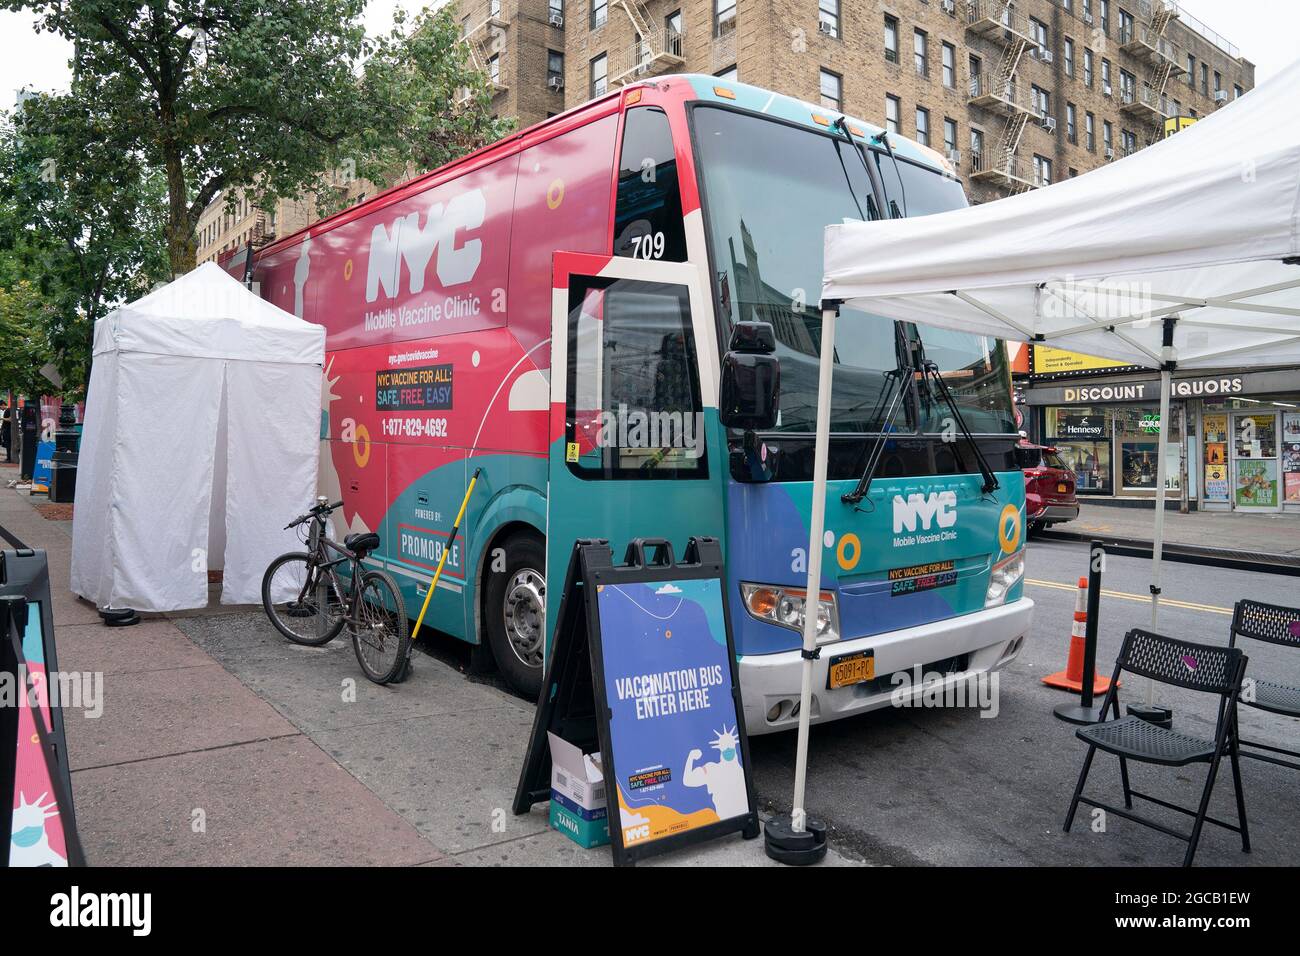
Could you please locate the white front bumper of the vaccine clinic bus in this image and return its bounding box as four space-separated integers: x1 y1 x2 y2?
738 597 1034 735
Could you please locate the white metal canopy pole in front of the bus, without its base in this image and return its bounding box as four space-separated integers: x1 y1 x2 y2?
790 308 840 834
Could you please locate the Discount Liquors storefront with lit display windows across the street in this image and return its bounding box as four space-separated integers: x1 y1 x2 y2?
1023 369 1300 512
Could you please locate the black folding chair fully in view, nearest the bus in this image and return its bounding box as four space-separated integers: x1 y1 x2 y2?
1065 628 1251 866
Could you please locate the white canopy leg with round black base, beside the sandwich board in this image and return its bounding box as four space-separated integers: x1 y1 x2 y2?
763 308 839 864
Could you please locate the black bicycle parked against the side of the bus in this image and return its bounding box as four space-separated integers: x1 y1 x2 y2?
261 498 411 684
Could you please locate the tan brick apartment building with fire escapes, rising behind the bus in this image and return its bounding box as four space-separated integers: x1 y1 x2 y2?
458 0 1255 202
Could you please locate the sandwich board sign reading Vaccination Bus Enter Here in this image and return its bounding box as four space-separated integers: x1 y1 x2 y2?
514 537 759 864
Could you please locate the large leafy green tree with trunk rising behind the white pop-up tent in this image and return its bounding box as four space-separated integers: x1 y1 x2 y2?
13 0 512 273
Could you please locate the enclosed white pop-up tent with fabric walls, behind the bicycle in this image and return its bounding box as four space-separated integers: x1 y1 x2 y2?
72 263 325 611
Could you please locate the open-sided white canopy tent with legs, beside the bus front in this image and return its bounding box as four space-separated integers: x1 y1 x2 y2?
769 61 1300 825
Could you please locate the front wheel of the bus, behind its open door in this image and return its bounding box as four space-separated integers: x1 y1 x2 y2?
484 533 546 700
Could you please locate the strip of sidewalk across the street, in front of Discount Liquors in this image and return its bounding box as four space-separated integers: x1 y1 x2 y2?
1052 501 1300 561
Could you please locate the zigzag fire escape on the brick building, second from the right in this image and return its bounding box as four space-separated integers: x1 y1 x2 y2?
966 0 1043 193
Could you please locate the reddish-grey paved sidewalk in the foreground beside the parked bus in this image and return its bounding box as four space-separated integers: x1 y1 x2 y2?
0 470 848 866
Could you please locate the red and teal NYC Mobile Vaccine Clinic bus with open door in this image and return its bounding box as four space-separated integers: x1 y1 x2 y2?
226 75 1032 734
